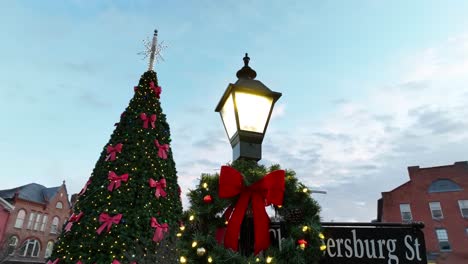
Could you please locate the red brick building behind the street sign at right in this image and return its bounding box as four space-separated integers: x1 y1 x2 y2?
377 161 468 264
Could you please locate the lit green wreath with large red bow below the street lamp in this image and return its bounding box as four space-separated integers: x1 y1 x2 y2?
177 159 325 264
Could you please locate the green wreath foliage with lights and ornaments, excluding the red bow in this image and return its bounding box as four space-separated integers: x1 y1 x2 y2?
177 160 325 264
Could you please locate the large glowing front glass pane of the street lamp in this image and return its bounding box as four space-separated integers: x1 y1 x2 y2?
236 92 273 133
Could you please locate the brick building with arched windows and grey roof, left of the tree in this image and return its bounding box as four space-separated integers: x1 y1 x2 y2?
0 182 70 264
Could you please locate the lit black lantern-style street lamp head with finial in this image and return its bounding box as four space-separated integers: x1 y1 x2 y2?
215 53 281 161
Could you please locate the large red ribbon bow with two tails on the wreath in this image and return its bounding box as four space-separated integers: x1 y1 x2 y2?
219 166 285 255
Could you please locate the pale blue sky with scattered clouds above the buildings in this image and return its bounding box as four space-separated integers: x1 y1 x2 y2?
0 0 468 221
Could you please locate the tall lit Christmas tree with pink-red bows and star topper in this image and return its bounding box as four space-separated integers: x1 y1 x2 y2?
49 31 182 264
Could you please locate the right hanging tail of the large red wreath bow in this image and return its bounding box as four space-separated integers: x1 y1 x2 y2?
252 194 270 255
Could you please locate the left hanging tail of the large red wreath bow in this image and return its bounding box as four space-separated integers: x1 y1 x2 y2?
224 193 250 251
